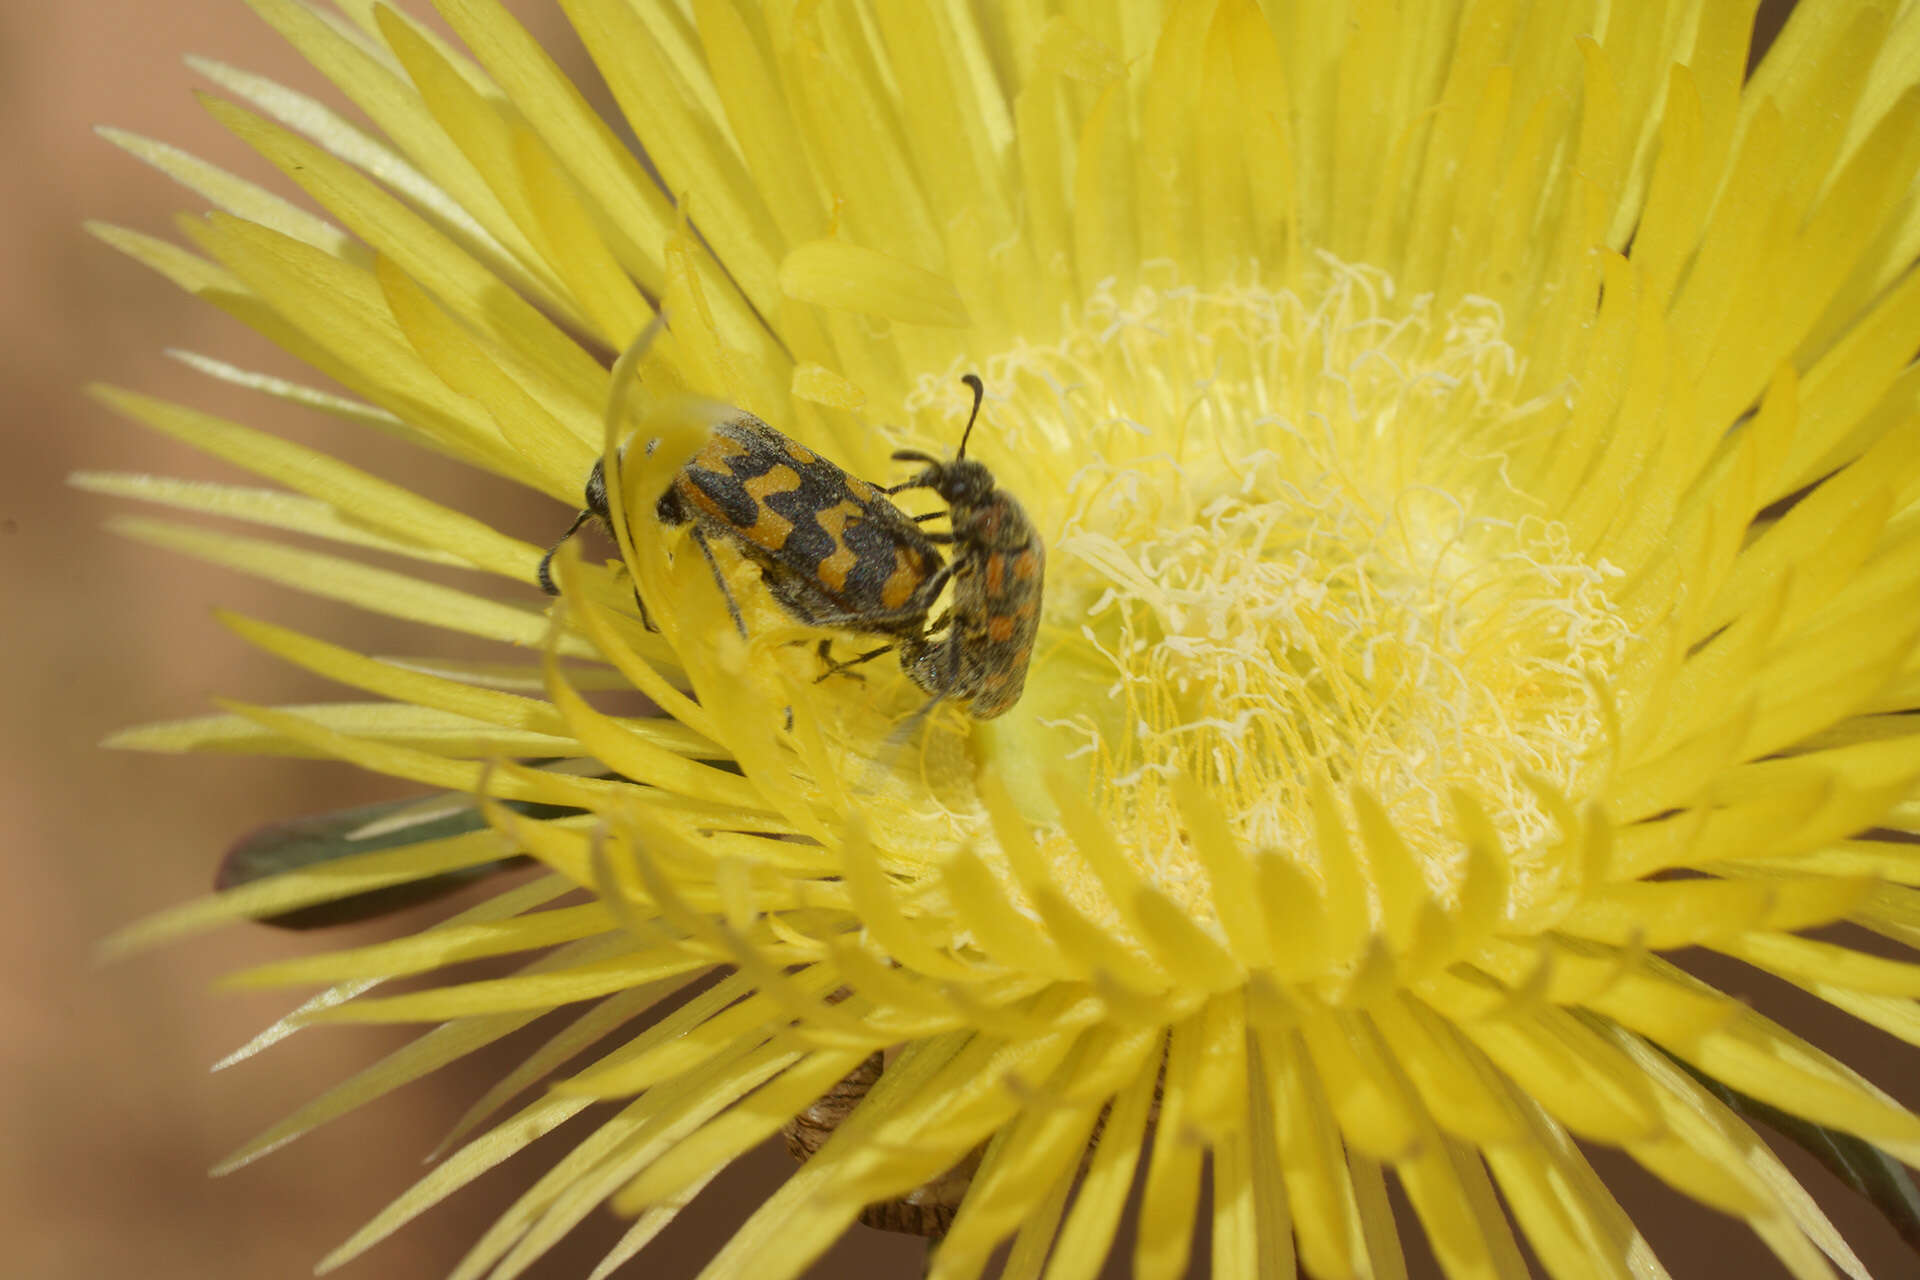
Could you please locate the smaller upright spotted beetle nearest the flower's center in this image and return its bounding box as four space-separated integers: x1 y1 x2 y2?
887 374 1046 720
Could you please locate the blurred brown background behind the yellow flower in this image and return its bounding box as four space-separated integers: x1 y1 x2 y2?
11 0 1914 1280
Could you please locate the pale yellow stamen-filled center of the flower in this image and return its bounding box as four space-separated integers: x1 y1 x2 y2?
952 261 1632 921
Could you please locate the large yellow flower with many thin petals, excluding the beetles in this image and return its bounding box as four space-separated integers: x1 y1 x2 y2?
88 0 1920 1280
